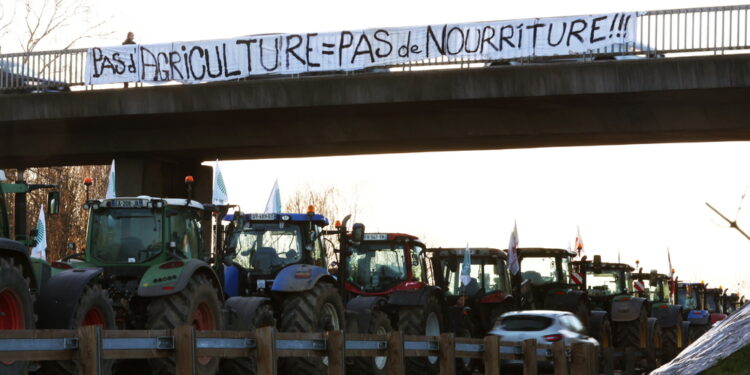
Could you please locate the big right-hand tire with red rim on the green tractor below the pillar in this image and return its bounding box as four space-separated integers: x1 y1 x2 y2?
146 274 223 375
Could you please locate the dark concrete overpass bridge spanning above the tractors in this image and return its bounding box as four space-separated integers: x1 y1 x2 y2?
0 5 750 200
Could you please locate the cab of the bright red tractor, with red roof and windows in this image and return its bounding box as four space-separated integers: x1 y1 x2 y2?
345 233 427 296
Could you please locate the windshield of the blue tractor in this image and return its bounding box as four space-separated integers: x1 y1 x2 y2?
229 223 302 275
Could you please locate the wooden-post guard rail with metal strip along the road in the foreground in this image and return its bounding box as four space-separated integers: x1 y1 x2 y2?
0 326 598 375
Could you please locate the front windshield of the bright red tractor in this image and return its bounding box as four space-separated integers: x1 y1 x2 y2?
347 242 407 292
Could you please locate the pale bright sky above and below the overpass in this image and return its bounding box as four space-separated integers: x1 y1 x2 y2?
5 0 750 295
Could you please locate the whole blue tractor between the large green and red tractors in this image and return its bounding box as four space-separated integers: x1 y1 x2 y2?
217 206 346 374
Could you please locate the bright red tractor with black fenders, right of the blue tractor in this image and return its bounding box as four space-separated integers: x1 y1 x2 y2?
337 232 450 374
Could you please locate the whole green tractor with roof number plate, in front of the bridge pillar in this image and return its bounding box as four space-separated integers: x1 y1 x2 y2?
58 176 224 374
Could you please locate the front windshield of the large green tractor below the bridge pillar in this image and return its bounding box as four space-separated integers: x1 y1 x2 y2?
89 208 162 263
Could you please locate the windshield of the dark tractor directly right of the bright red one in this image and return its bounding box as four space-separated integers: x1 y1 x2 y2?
442 256 505 297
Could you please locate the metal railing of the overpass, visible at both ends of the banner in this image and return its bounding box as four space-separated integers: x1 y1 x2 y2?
0 5 750 93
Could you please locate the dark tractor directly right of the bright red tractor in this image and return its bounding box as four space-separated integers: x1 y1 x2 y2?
427 248 515 337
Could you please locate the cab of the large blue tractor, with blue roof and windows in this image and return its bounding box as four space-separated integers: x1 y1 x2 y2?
224 212 328 297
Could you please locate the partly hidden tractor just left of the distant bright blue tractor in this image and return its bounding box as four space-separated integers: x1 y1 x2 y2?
633 269 690 363
